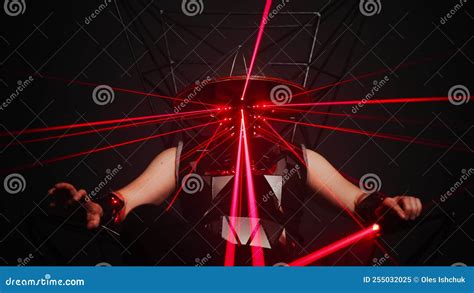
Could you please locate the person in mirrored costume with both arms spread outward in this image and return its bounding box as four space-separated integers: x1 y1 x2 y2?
49 77 422 265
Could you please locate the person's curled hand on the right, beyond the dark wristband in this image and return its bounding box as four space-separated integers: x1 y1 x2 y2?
376 195 423 220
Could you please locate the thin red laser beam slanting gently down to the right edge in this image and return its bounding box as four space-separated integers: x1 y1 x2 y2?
264 117 469 151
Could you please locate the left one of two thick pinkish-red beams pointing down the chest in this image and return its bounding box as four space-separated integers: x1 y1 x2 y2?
224 113 243 266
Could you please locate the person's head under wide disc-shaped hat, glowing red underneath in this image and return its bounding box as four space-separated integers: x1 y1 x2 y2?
174 76 308 137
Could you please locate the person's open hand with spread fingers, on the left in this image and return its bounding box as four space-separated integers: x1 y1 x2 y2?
48 182 103 229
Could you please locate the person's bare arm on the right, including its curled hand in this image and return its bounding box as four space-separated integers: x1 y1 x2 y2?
306 150 422 220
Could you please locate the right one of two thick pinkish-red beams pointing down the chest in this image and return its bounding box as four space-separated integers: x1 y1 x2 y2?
240 110 265 266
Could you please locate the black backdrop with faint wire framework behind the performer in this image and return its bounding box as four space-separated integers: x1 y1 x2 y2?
0 0 474 265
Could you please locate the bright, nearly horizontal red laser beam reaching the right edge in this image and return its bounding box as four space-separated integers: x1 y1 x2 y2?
263 97 458 108
